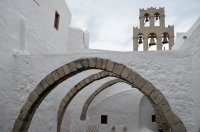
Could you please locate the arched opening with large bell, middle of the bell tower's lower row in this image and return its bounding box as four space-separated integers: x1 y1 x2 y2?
148 33 157 50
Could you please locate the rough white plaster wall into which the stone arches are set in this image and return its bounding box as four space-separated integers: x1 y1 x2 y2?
0 50 195 132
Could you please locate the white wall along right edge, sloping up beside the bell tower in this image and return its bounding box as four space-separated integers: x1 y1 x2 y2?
174 18 200 131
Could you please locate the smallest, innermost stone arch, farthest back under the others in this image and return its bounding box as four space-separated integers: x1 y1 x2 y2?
80 79 162 129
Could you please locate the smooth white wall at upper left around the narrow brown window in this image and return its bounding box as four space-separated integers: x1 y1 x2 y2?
0 0 89 54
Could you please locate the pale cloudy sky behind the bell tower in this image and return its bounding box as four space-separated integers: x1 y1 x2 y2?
66 0 200 51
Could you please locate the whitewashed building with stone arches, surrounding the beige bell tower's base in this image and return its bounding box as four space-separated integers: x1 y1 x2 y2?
0 0 200 132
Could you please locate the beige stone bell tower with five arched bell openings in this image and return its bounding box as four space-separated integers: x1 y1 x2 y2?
133 7 174 51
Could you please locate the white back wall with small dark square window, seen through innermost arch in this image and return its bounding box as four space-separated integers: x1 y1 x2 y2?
86 88 142 132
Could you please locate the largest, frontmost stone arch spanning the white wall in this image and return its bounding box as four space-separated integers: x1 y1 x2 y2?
13 58 186 132
